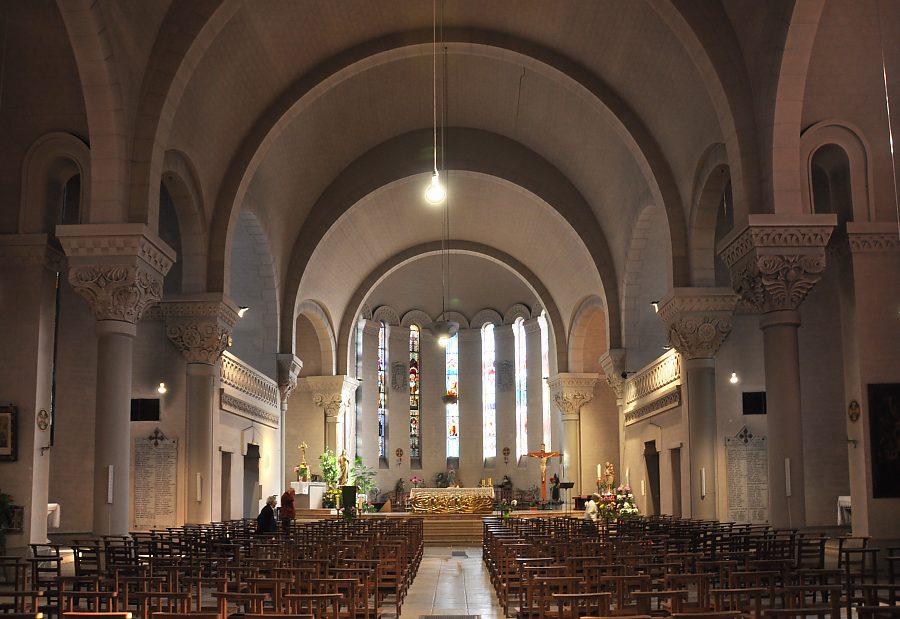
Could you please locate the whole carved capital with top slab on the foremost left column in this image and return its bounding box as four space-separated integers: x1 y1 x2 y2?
56 224 175 324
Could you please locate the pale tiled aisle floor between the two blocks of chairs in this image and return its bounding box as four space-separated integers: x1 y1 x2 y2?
398 546 503 619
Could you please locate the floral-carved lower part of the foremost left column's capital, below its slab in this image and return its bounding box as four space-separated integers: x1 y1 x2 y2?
69 264 163 324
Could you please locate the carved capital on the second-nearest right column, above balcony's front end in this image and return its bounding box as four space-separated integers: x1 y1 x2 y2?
659 288 738 359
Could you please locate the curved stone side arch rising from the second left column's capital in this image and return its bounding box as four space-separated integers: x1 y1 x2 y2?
161 150 208 293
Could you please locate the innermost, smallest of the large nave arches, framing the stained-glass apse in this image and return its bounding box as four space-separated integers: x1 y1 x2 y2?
337 240 568 374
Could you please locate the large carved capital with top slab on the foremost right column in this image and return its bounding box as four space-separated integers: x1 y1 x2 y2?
719 215 837 313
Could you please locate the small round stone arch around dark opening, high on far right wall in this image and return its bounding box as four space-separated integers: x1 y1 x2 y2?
800 120 875 221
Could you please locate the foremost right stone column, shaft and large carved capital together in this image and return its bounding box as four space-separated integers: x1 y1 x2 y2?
720 215 836 528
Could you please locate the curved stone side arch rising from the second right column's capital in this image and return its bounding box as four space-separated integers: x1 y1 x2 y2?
690 143 730 286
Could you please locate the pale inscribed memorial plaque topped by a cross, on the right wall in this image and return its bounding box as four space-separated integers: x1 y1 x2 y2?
725 426 769 524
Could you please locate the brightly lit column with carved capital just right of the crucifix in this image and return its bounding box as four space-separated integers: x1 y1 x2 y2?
550 373 599 496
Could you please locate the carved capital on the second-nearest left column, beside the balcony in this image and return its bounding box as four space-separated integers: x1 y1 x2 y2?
160 293 238 365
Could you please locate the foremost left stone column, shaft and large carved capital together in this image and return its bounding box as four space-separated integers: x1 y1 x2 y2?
56 224 175 535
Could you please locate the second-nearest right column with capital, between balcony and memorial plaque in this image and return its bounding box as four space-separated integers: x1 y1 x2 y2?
659 288 738 520
